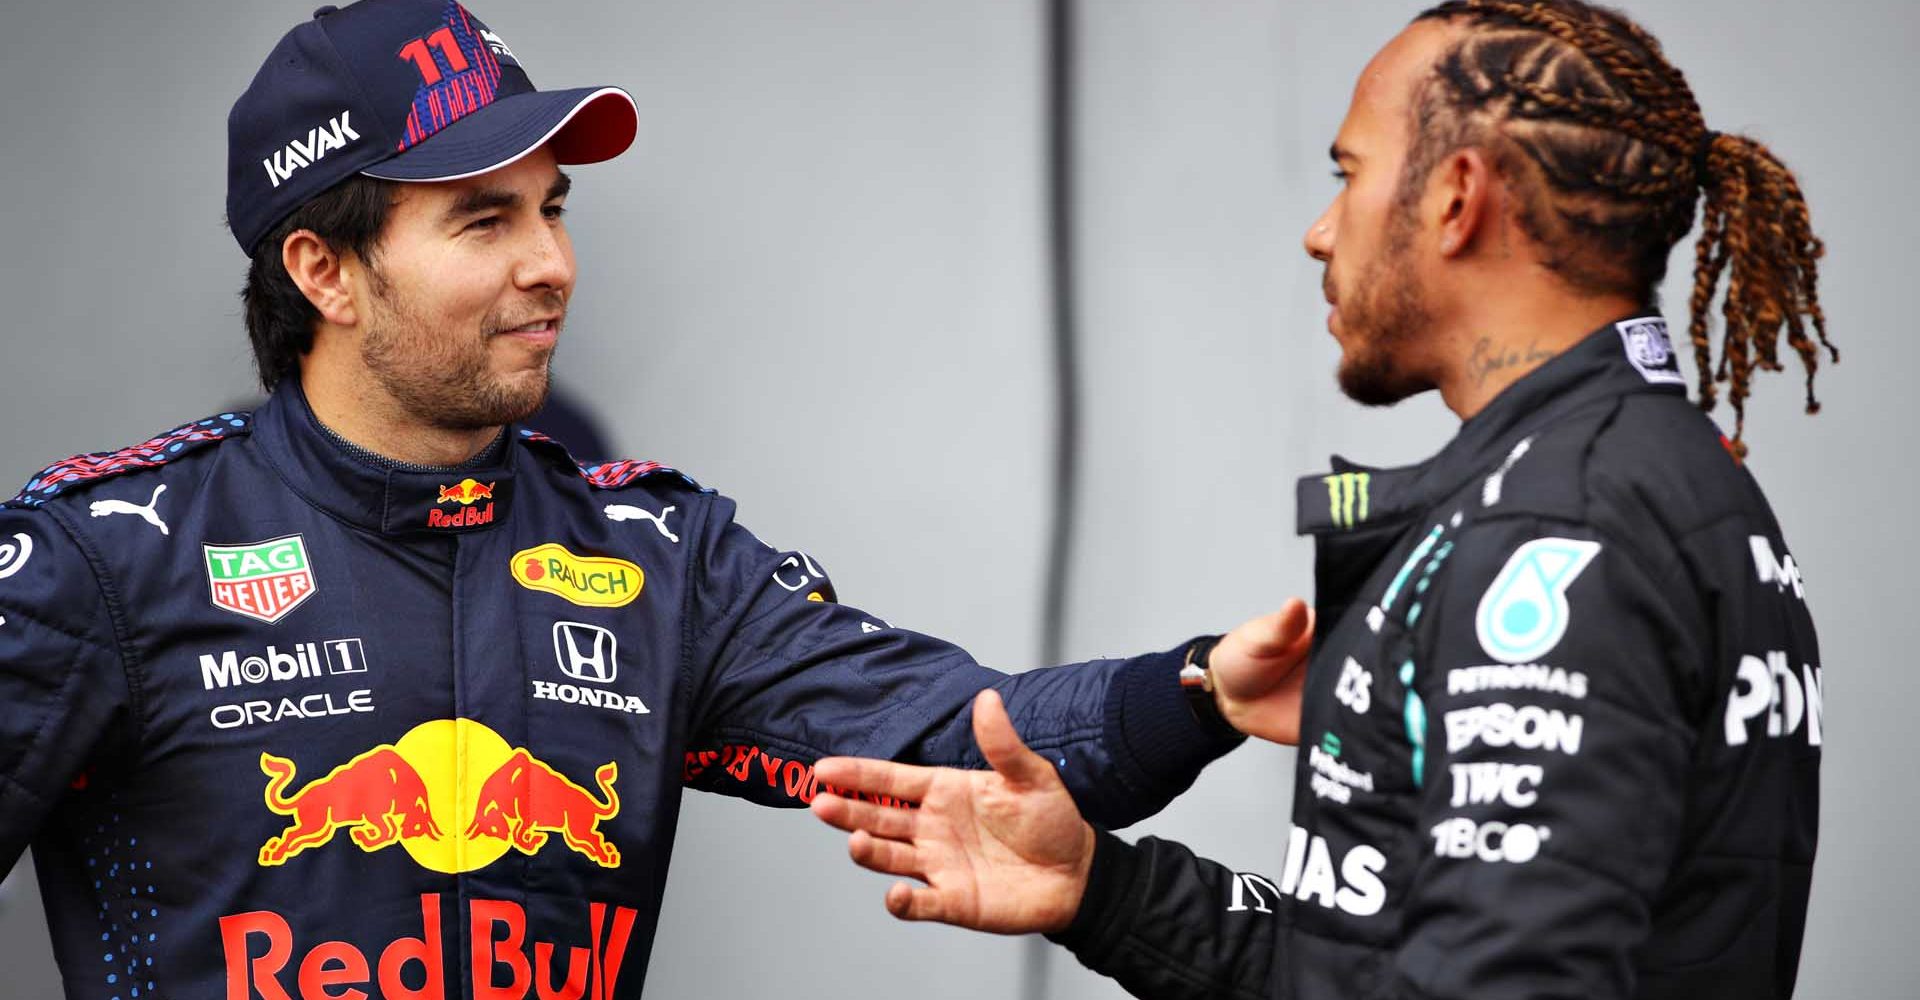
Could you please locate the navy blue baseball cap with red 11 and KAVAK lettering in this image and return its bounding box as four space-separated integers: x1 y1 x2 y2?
227 0 639 253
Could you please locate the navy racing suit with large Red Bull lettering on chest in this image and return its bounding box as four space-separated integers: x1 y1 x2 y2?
0 382 1233 1000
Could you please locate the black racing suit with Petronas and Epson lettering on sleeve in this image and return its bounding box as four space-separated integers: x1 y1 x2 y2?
1058 317 1822 1000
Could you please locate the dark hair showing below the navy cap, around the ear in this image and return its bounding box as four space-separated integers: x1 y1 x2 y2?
240 175 396 392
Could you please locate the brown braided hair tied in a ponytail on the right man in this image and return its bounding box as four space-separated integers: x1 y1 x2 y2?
1402 0 1839 457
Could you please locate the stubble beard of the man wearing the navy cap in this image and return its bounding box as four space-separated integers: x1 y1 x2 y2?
361 276 553 430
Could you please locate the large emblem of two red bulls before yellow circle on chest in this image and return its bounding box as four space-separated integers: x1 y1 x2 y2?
259 718 620 873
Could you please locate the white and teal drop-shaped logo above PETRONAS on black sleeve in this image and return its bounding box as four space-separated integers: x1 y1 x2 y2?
1475 537 1599 664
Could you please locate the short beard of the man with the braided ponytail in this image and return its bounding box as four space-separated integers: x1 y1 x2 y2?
1336 204 1434 407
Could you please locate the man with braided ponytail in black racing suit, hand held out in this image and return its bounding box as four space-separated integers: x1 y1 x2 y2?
812 0 1824 1000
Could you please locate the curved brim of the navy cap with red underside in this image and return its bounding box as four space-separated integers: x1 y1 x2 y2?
361 86 639 180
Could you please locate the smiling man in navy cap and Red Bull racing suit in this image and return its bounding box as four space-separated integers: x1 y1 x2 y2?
0 0 1308 1000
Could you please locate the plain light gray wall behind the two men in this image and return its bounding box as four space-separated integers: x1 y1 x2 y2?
0 0 1920 1000
